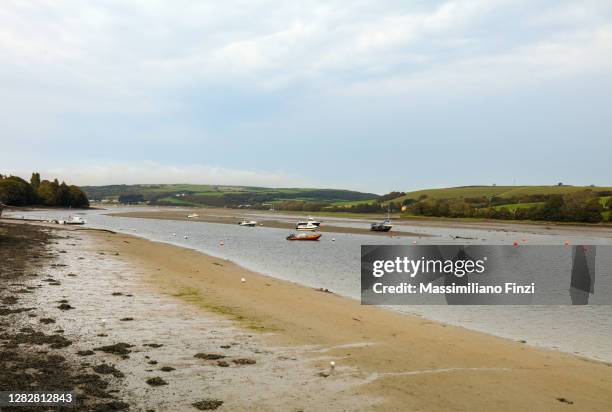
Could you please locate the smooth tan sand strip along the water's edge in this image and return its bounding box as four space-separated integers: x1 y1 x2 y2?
85 225 612 410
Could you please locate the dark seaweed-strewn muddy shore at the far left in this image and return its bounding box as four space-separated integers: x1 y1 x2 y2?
0 220 128 411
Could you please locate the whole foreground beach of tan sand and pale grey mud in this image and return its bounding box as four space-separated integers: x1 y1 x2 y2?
2 225 612 411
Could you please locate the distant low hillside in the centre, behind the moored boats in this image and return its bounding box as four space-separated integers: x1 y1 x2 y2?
83 184 378 208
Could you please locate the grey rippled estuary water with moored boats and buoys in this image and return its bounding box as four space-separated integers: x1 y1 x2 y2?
5 208 612 362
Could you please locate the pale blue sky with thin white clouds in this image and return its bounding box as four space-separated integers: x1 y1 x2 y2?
0 0 612 193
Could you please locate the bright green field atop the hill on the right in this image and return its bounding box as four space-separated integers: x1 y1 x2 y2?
393 186 612 202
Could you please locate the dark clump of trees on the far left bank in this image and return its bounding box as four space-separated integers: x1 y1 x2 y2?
0 173 89 207
